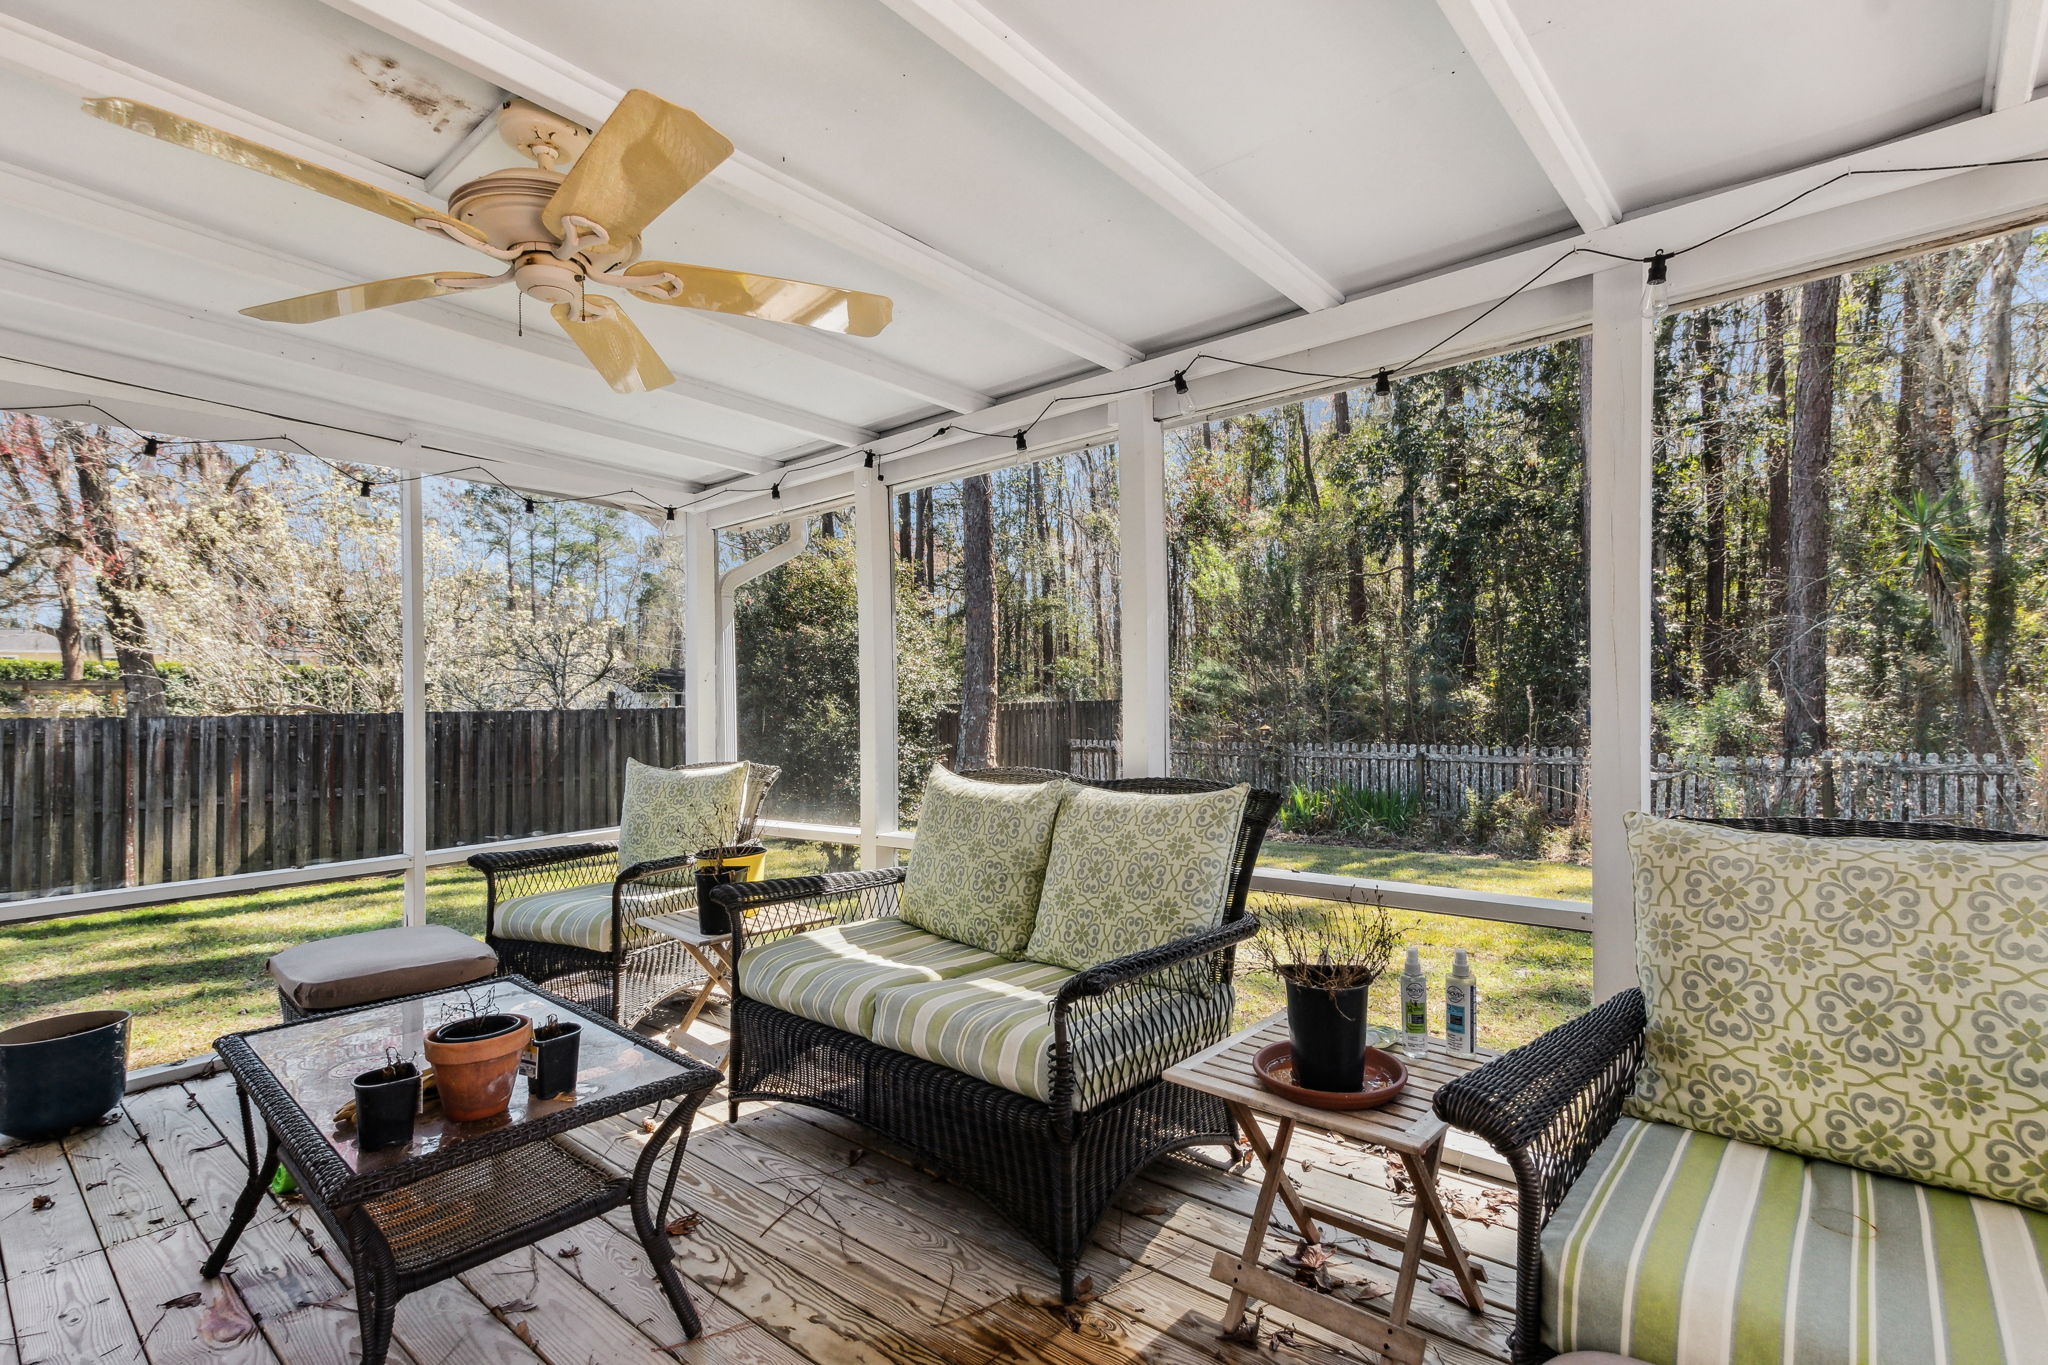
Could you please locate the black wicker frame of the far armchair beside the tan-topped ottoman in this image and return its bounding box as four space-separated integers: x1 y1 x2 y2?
469 763 782 1023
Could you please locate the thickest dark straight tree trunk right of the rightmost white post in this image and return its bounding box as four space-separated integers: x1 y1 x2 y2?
1784 276 1841 755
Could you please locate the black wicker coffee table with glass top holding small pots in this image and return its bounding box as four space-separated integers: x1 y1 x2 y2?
203 976 719 1365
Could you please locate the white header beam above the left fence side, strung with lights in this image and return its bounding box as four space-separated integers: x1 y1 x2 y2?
0 258 776 475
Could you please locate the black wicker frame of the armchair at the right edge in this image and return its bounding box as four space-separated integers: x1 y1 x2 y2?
1436 817 2044 1365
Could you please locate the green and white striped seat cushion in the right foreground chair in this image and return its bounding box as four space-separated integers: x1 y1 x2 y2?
1542 1117 2048 1365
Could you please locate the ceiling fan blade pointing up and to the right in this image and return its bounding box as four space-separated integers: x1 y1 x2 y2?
541 90 733 241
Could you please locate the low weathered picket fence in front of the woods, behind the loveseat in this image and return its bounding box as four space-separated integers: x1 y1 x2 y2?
1067 739 2040 827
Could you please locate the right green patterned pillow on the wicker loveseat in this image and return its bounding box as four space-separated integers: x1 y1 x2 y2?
1024 784 1251 972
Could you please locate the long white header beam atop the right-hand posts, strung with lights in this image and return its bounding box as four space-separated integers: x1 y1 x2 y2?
702 87 2048 526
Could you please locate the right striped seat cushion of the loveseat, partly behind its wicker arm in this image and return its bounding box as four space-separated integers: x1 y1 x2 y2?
868 962 1233 1109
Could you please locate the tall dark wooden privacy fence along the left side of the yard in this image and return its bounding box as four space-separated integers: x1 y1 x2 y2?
0 708 682 898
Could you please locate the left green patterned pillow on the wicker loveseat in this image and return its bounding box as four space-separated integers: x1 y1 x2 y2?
897 765 1071 958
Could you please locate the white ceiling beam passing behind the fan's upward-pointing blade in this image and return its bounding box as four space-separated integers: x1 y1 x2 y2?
307 0 1139 368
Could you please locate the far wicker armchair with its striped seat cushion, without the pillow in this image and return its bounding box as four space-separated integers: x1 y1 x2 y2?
469 763 782 1023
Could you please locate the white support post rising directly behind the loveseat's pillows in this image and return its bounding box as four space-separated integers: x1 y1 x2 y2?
1116 389 1174 778
